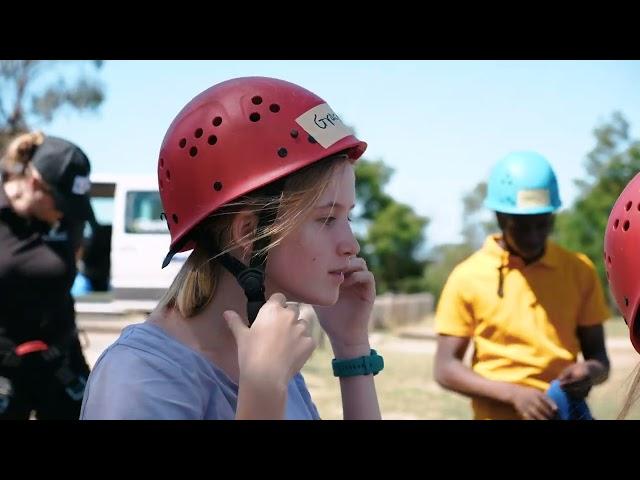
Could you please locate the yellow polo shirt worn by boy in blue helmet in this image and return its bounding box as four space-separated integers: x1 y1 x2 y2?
435 235 610 419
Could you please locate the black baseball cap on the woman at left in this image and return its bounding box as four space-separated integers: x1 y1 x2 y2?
31 137 94 222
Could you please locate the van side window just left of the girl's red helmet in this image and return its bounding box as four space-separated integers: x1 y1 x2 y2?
125 191 169 233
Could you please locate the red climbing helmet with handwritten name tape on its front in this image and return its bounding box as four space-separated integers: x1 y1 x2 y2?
158 77 367 264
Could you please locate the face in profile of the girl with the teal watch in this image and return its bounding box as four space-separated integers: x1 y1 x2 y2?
266 162 360 305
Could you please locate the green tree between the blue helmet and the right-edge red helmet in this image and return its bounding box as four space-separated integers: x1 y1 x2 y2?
554 112 640 287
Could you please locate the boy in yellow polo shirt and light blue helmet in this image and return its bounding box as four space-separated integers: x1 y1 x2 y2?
434 152 610 419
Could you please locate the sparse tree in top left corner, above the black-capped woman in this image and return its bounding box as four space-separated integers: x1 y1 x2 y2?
0 60 104 148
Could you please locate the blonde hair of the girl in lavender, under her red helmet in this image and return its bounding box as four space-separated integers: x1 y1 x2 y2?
159 154 348 318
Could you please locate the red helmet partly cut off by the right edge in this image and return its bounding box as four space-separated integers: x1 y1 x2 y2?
604 173 640 353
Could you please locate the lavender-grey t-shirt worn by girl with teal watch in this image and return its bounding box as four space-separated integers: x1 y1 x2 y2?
80 323 320 420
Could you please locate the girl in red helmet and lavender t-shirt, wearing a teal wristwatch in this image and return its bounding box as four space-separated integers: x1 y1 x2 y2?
81 77 383 419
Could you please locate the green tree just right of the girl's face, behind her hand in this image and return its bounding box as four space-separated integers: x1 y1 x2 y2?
354 159 429 293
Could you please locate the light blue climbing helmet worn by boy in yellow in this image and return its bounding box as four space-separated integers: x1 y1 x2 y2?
484 152 562 215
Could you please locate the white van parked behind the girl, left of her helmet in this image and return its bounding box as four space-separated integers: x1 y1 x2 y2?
76 175 190 313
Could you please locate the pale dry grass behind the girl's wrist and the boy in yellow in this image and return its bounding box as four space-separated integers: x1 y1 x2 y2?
303 320 640 419
